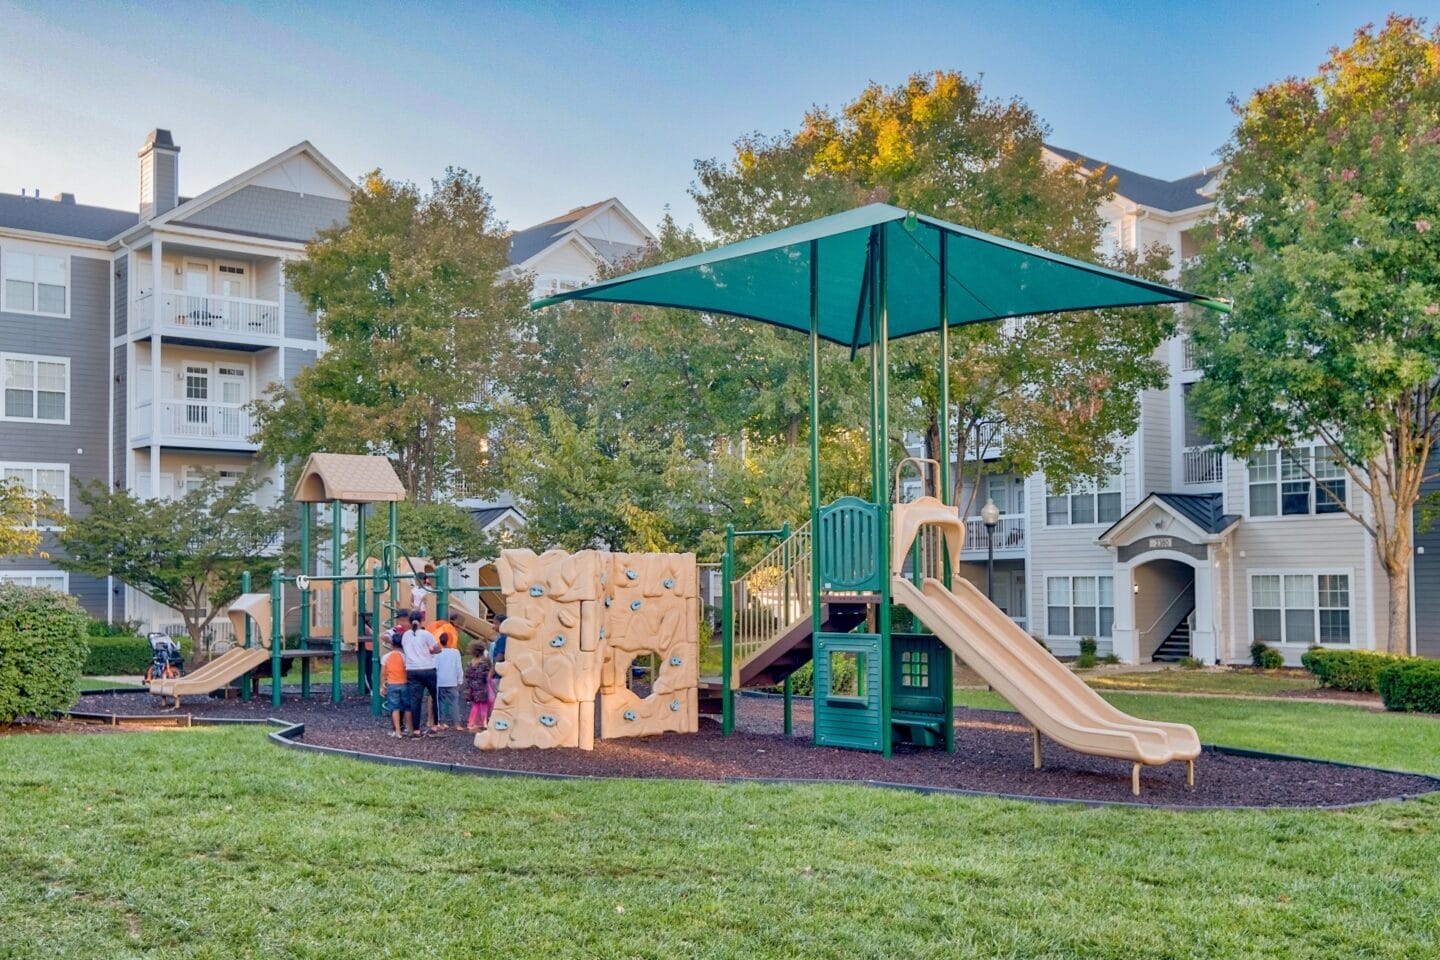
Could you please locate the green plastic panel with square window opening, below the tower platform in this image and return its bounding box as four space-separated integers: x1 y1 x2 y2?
815 633 883 751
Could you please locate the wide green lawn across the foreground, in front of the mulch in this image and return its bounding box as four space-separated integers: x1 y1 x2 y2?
0 719 1440 960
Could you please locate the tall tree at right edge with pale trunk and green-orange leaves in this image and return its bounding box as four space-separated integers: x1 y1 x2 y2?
1191 16 1440 653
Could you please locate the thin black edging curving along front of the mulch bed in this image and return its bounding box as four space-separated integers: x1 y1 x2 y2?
262 718 1440 812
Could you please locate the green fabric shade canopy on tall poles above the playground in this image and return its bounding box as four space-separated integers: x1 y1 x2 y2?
530 203 1228 348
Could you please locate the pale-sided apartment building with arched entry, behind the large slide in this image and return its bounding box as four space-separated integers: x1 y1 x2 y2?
944 147 1440 664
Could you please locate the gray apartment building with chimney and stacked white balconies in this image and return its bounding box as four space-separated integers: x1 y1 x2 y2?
0 130 353 628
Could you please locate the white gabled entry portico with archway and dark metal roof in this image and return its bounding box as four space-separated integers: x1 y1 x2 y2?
1099 494 1240 664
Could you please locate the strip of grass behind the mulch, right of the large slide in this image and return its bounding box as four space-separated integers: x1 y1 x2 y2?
955 689 1440 777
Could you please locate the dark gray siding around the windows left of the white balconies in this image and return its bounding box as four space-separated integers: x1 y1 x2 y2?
0 249 111 613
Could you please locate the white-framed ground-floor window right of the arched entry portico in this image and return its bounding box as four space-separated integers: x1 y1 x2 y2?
1250 573 1351 646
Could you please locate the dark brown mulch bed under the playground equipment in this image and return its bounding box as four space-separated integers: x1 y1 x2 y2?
76 694 1437 807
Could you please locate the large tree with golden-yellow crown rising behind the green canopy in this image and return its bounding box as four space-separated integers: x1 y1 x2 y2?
694 72 1174 512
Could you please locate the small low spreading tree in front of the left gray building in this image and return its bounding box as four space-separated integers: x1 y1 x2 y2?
56 474 285 649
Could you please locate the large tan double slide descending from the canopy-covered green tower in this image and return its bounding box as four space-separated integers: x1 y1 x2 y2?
891 576 1200 794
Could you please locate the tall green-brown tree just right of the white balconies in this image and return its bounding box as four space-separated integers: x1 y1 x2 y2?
256 170 528 502
